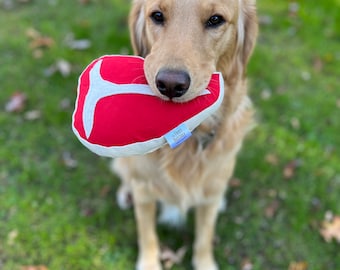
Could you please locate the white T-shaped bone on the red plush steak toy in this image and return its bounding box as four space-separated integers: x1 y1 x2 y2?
83 60 210 138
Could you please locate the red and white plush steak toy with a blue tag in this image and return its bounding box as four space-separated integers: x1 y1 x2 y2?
72 55 224 157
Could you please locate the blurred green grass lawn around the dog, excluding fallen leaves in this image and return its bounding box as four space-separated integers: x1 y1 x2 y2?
0 0 340 270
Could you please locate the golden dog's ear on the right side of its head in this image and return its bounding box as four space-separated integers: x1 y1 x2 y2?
238 0 258 67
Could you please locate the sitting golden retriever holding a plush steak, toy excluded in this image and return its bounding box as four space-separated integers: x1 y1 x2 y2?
113 0 258 270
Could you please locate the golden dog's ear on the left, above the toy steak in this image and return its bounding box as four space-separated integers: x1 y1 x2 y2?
129 0 148 57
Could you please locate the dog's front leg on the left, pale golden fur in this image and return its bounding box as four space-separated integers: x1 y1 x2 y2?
133 182 161 270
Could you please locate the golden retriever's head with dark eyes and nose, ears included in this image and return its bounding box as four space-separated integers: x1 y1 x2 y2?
130 0 257 102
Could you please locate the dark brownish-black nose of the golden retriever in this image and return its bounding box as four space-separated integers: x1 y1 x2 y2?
156 69 190 99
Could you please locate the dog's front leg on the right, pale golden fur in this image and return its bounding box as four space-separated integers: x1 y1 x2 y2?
193 201 220 270
